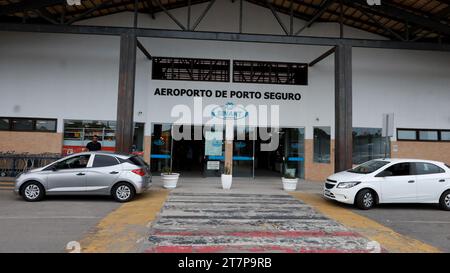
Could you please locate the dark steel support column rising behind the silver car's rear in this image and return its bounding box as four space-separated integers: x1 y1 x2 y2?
116 33 137 153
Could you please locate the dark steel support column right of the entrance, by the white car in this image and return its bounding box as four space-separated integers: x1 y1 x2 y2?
334 45 353 172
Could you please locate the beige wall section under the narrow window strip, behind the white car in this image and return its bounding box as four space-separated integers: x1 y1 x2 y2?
391 141 450 164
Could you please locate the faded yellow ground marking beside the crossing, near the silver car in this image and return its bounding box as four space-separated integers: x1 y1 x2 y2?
80 189 169 253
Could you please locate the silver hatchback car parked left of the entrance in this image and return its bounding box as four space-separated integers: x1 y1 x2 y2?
14 152 152 202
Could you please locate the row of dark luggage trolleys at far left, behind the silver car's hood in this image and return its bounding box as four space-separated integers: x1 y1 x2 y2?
0 152 61 177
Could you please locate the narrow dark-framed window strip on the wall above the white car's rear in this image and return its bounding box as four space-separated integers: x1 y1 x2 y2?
397 129 450 141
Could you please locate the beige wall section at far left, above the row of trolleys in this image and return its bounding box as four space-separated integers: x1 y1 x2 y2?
0 131 63 154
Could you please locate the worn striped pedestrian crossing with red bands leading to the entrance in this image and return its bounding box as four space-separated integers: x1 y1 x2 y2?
144 192 369 253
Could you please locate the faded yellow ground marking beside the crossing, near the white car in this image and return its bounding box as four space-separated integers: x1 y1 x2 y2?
291 192 441 253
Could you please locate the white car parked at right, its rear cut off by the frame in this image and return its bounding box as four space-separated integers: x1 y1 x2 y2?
323 159 450 210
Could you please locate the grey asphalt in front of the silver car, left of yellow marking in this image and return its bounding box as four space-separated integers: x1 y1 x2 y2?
0 190 120 252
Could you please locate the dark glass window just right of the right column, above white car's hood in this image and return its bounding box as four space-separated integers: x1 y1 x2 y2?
353 128 390 164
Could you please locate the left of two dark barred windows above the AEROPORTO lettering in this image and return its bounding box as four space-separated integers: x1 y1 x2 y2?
152 57 230 82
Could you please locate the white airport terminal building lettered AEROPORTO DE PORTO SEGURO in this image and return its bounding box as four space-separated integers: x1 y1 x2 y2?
0 0 450 181
